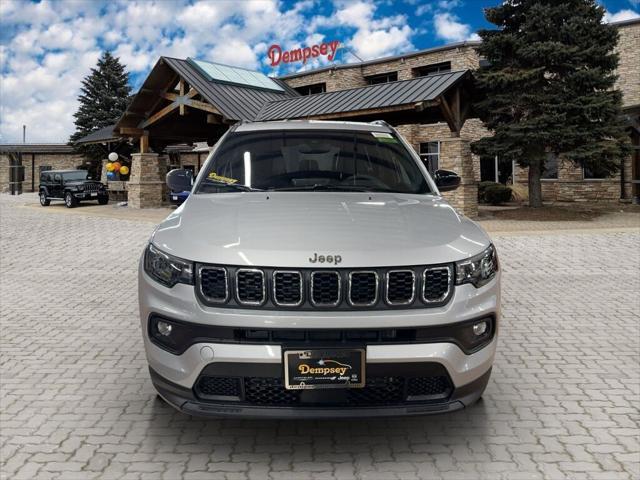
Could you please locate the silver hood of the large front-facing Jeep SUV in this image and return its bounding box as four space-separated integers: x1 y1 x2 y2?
152 192 489 268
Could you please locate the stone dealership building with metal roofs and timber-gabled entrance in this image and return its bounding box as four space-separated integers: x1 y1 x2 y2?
0 19 640 216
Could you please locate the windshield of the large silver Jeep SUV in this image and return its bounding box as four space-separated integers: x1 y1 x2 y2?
196 130 430 194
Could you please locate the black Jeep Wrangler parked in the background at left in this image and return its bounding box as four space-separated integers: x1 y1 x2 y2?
39 170 109 208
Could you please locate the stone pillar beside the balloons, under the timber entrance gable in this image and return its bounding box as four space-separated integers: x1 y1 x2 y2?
127 153 167 208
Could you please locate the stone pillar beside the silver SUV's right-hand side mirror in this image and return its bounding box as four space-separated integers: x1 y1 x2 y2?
439 137 479 218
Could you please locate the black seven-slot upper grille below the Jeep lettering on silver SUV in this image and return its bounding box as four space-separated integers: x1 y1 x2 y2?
196 264 453 310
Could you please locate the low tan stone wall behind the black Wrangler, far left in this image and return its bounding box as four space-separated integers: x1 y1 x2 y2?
0 153 84 192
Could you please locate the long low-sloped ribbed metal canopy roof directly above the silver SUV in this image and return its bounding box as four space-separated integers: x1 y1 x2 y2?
256 70 469 121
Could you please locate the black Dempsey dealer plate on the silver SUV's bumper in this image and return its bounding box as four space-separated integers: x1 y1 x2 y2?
284 348 366 390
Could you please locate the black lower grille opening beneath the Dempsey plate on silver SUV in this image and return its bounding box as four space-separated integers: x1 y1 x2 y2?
195 376 453 407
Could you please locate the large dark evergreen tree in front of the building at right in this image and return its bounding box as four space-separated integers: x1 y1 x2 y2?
471 0 630 207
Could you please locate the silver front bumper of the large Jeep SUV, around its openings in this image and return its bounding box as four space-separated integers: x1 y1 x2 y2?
139 262 500 418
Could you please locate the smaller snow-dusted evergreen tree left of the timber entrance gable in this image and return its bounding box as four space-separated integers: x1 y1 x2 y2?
69 51 131 160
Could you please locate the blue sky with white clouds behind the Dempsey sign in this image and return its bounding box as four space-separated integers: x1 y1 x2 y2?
0 0 640 143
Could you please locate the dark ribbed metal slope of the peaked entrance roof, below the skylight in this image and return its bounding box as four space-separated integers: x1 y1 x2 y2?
162 57 297 120
